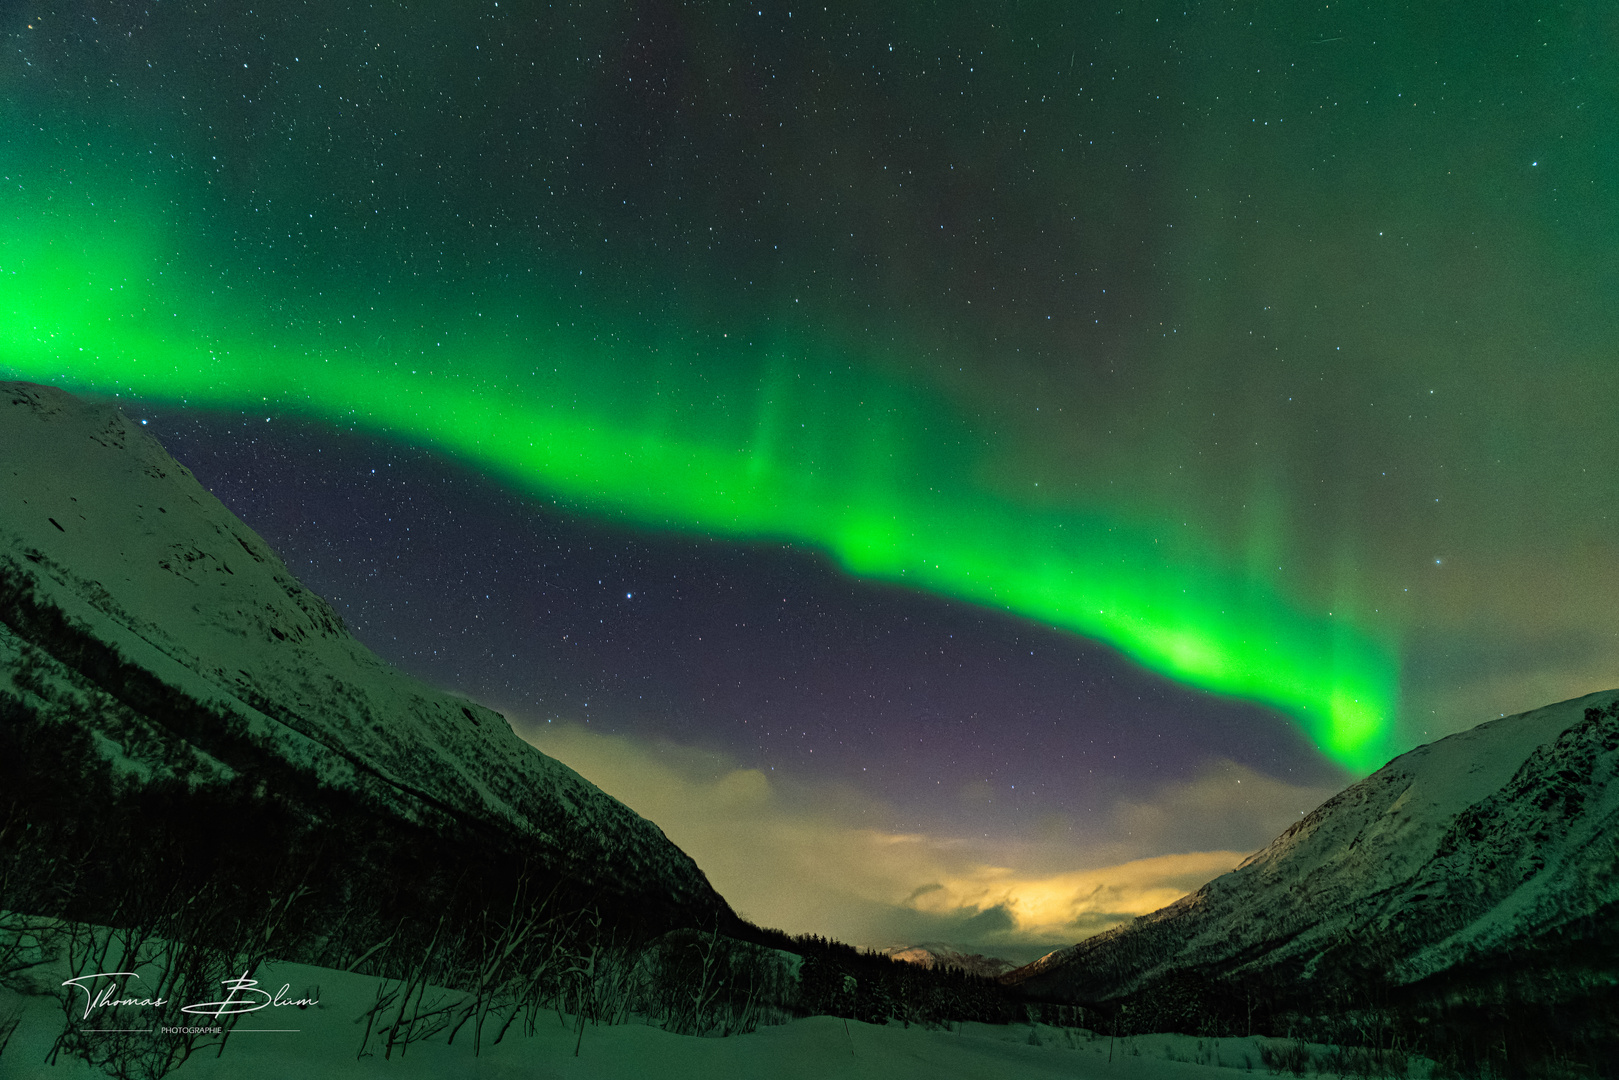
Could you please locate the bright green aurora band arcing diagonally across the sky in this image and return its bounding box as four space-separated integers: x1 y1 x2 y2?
0 159 1399 771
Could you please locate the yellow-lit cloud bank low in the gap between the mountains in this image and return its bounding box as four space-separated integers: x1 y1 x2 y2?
508 712 1331 959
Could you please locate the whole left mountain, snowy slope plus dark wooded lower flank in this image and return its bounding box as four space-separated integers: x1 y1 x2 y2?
0 382 735 952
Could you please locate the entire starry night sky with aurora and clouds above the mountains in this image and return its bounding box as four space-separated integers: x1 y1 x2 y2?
0 0 1619 944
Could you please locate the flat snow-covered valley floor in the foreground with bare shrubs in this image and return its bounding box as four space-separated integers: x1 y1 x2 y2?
0 963 1428 1080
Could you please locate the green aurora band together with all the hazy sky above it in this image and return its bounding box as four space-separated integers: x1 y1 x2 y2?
0 0 1619 939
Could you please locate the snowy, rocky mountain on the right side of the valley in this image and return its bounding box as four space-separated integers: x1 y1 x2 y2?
1007 691 1619 1062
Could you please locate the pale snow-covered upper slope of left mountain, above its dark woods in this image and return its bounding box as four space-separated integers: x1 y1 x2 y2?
0 382 729 925
